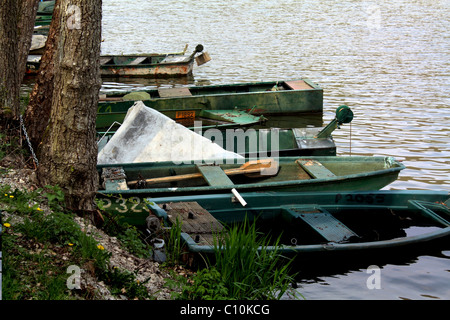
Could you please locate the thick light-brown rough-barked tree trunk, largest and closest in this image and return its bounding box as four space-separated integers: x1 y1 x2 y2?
38 0 102 210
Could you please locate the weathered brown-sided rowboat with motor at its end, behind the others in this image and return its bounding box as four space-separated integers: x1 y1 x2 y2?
26 45 210 78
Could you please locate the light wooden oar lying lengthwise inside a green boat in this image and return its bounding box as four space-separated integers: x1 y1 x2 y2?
128 159 279 185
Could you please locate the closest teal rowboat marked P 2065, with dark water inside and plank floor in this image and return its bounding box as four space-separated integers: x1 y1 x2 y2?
140 190 450 254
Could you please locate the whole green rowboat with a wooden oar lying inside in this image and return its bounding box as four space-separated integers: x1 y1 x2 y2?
97 155 405 200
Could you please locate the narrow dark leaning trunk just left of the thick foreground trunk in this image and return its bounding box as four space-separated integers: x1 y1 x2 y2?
25 0 60 151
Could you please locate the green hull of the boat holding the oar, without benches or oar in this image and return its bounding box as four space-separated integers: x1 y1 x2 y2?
97 156 405 201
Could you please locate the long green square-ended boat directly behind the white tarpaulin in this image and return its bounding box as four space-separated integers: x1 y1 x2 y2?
97 79 323 117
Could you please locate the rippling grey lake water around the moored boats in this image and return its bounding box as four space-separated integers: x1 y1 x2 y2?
102 0 450 299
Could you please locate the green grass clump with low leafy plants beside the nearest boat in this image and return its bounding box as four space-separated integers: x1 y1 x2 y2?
169 221 298 300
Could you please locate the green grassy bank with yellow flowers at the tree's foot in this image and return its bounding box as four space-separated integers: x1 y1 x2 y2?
0 185 151 300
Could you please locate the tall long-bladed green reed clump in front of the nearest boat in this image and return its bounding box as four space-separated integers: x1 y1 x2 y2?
214 220 293 300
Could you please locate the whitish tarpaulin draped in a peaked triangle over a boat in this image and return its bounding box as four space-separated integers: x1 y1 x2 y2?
98 101 243 164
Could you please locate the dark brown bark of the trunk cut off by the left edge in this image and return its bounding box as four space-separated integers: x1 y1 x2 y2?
0 0 21 118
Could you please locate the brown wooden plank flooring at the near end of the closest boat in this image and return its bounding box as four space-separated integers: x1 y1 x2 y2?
161 202 223 245
